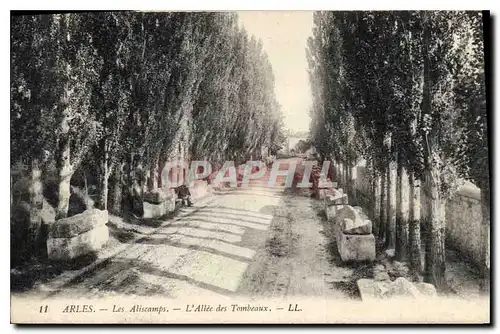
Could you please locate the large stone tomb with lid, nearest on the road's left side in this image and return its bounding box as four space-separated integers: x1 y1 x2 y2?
47 209 109 261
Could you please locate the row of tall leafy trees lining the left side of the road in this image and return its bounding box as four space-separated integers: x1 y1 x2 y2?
11 12 283 262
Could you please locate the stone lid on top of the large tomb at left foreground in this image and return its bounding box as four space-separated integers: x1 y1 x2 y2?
48 209 108 238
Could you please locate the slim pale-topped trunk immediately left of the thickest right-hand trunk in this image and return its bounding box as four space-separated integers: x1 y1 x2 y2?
408 174 422 278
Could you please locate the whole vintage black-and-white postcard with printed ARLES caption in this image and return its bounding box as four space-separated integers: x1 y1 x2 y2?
10 10 492 324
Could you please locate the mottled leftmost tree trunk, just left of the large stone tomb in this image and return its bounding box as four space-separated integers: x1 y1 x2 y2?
27 158 43 256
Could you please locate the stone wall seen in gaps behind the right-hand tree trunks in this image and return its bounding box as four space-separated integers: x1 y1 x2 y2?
354 166 482 265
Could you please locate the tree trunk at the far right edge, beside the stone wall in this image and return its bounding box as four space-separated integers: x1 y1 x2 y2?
480 180 491 294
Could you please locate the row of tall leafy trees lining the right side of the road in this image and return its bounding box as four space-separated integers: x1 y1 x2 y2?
307 11 490 289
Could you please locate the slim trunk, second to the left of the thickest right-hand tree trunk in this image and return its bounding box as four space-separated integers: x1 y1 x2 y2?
396 163 409 261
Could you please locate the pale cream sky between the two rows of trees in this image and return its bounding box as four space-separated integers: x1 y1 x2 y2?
238 11 313 131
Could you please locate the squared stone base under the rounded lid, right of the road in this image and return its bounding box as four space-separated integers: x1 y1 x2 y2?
337 232 375 262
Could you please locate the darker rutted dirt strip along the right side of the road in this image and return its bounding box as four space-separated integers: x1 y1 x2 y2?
240 195 352 298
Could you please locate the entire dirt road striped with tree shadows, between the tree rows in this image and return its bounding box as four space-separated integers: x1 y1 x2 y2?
38 159 352 298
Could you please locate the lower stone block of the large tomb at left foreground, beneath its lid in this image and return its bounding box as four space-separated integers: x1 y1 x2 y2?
47 222 109 261
